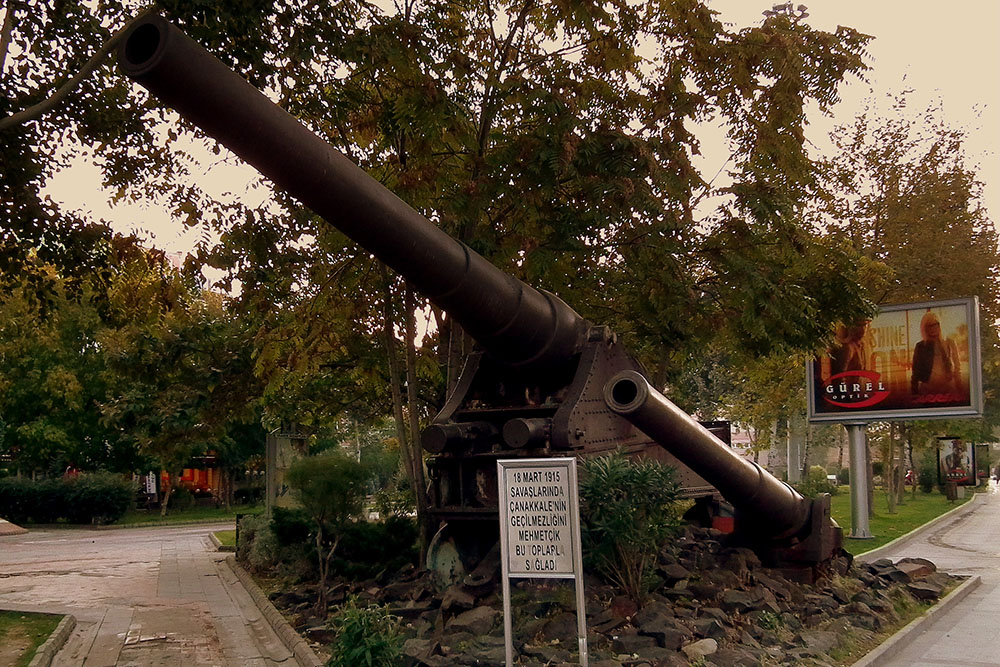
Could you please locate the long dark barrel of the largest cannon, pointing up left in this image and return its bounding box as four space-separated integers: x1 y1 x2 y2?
118 16 589 366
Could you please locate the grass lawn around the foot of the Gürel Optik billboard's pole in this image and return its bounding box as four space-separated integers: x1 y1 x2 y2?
831 486 975 556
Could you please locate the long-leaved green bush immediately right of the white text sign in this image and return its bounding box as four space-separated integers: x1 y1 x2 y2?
580 452 680 604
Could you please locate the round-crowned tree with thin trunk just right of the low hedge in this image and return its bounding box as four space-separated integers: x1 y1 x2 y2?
101 250 262 514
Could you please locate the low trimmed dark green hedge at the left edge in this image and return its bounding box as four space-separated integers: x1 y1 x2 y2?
0 473 135 524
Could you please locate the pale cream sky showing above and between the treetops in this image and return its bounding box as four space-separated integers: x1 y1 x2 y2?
47 0 1000 252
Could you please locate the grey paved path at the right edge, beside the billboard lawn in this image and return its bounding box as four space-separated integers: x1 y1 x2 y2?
856 482 1000 667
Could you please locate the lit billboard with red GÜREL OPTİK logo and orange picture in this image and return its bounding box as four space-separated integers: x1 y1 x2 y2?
806 299 983 422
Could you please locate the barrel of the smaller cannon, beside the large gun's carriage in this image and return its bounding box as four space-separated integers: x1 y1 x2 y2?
604 371 811 540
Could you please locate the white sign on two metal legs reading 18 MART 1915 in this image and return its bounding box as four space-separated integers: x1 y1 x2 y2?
497 458 588 667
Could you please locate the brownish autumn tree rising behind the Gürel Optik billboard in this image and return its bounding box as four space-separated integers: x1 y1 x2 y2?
815 91 1000 506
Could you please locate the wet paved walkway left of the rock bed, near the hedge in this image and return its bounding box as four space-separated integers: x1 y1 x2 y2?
0 525 297 667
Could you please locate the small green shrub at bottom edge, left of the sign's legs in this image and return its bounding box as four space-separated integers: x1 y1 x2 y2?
326 597 403 667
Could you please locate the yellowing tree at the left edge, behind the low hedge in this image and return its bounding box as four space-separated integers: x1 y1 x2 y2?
0 266 136 475
